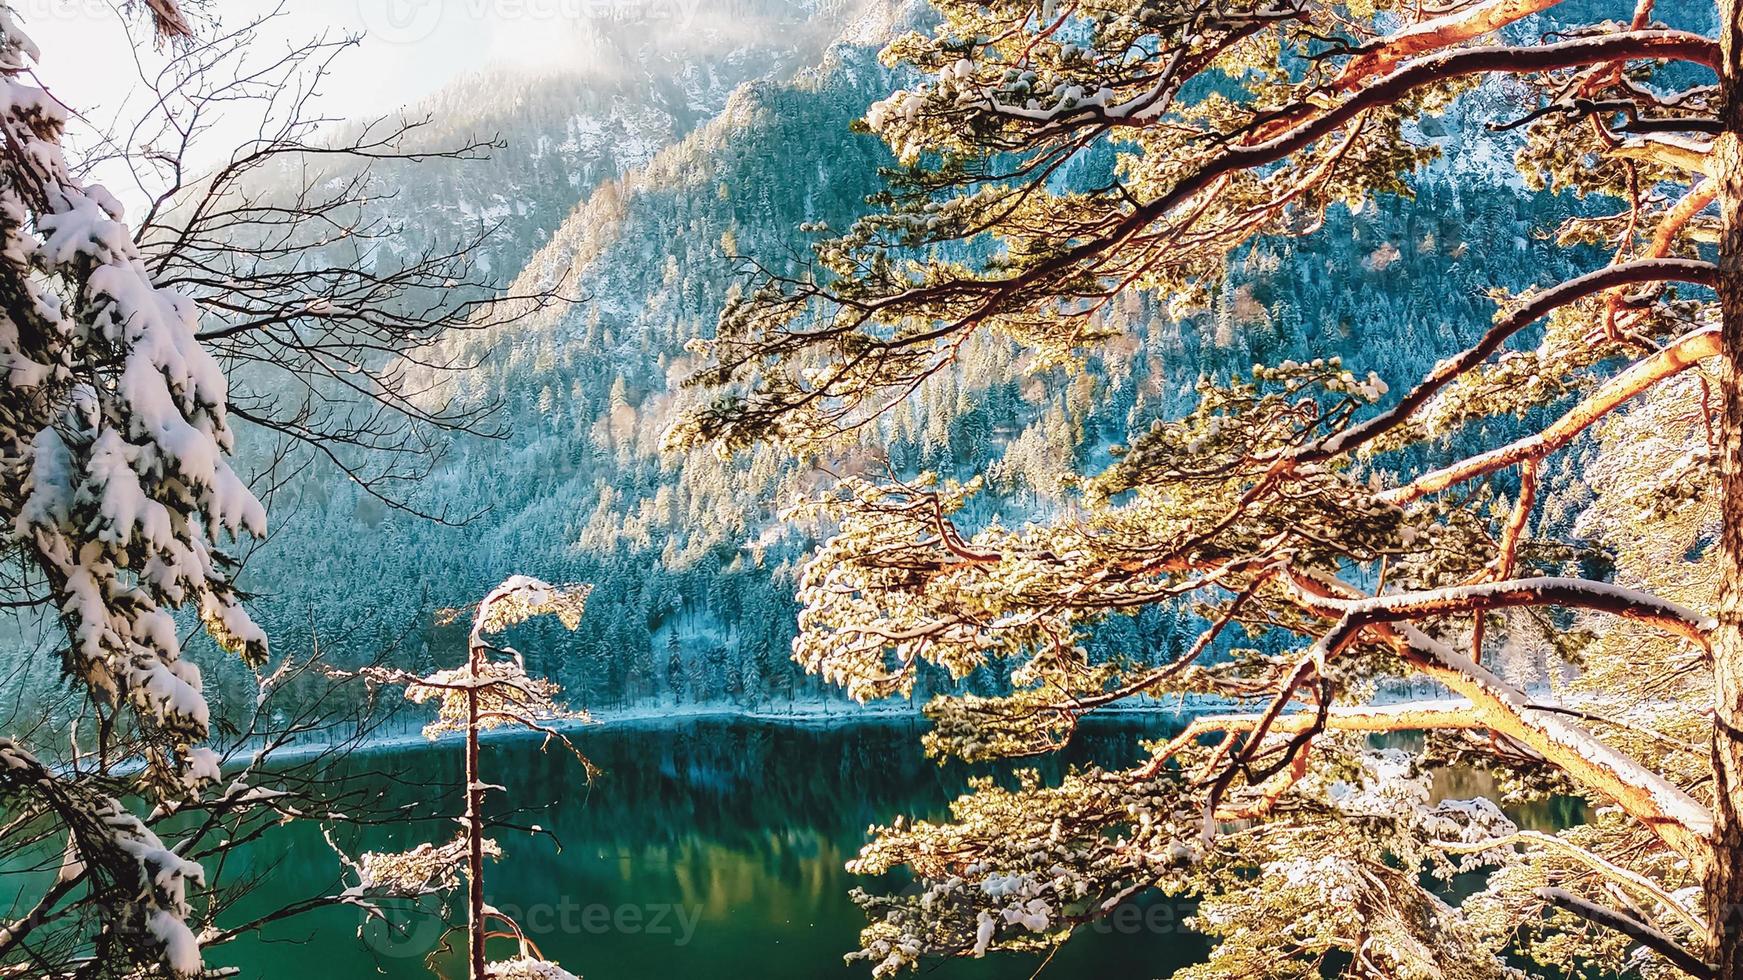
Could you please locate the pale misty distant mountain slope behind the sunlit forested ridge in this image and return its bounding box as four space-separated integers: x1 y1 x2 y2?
357 0 899 272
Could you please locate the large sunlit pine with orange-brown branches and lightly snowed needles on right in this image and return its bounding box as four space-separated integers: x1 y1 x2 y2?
671 0 1743 980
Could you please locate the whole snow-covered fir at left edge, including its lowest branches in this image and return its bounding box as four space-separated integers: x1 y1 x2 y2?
0 0 267 977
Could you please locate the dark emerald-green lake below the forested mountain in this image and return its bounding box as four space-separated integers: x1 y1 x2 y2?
209 717 1577 980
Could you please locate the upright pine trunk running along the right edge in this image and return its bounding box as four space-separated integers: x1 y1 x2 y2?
1703 0 1743 980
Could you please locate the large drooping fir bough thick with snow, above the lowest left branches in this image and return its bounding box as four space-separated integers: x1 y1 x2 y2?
0 3 267 777
